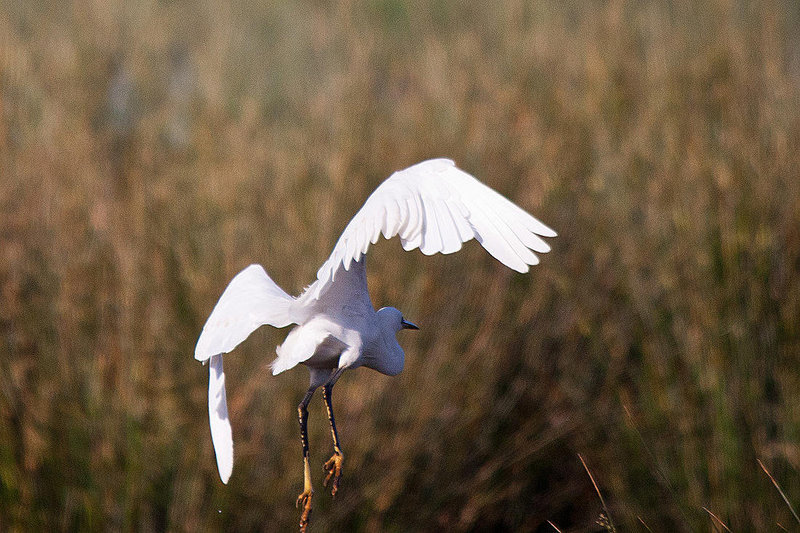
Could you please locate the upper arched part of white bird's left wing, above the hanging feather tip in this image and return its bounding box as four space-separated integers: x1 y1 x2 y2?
194 265 295 361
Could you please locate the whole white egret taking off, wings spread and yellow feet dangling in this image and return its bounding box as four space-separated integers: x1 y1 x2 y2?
194 159 556 532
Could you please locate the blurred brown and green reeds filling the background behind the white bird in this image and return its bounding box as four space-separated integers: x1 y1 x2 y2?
0 0 800 532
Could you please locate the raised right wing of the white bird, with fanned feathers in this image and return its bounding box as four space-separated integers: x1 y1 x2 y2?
309 159 556 298
